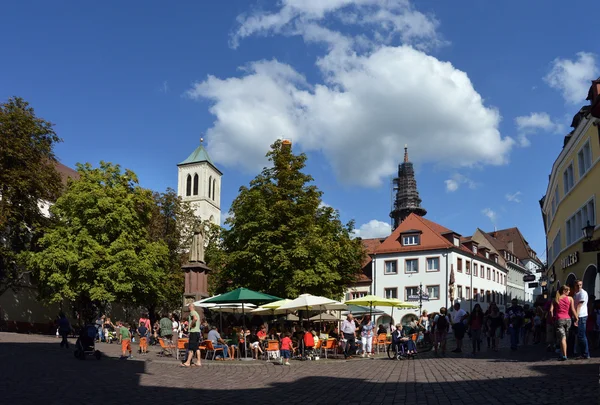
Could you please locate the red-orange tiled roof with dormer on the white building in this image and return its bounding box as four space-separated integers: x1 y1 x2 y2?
375 214 454 253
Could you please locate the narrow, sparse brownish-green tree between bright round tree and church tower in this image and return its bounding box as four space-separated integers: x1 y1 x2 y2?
144 188 201 314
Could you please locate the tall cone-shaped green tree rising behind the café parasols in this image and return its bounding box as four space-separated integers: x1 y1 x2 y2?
209 141 365 298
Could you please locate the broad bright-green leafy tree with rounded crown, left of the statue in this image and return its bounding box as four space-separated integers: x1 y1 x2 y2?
29 162 169 320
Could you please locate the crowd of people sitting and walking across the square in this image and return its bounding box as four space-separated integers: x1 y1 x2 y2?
57 280 600 367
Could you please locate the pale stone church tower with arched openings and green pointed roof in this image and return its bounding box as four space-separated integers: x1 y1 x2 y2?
177 138 223 225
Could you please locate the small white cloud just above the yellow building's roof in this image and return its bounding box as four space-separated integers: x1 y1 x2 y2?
544 52 599 104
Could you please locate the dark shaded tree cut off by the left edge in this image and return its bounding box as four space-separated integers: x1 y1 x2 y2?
0 98 62 295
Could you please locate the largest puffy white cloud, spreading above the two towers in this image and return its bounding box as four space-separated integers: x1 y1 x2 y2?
187 0 514 186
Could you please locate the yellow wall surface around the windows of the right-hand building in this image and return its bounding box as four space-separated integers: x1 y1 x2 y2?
544 117 600 283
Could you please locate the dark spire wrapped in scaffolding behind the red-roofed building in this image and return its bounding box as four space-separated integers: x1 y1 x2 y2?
390 145 427 230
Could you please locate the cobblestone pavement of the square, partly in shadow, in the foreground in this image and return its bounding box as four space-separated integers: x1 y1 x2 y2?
0 333 600 405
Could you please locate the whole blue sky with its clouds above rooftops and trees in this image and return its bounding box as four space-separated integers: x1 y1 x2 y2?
0 0 600 255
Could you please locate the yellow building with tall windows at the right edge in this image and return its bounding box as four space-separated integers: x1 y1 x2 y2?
540 81 600 299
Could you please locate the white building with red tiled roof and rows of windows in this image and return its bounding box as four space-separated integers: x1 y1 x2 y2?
364 214 508 323
